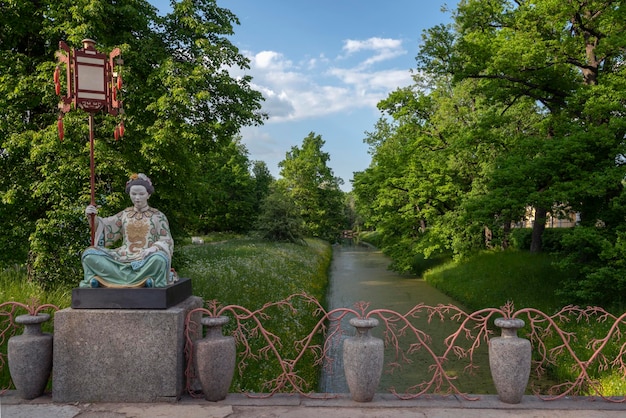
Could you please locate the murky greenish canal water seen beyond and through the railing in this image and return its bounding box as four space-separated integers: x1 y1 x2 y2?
320 245 495 394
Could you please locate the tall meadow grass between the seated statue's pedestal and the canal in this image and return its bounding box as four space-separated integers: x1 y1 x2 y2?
179 237 332 392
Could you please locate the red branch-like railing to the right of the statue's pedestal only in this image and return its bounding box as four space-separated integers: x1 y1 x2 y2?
182 294 626 402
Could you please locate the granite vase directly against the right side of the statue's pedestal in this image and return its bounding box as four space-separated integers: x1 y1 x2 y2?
194 316 237 401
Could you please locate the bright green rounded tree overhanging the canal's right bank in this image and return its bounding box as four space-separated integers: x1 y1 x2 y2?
353 80 524 270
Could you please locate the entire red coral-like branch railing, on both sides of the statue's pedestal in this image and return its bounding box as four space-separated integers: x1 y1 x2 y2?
0 294 626 402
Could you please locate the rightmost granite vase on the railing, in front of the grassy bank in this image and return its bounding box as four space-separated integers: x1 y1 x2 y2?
489 318 531 404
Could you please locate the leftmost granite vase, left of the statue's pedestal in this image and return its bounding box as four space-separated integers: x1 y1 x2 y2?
7 313 53 399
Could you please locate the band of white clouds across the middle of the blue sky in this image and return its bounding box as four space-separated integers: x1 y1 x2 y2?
234 38 411 123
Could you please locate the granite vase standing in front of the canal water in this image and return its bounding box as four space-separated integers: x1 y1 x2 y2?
343 318 385 402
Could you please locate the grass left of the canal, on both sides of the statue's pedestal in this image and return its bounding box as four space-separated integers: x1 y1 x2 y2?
0 234 332 392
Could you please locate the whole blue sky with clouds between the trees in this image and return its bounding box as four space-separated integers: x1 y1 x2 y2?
149 0 457 191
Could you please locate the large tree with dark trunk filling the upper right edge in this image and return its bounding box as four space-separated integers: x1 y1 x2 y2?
431 0 626 309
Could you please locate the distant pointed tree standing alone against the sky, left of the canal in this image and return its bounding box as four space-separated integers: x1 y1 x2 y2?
277 132 346 241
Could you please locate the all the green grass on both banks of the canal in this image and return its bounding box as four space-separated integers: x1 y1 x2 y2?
0 235 626 396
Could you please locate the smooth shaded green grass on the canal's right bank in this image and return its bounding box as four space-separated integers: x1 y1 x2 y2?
424 251 626 396
